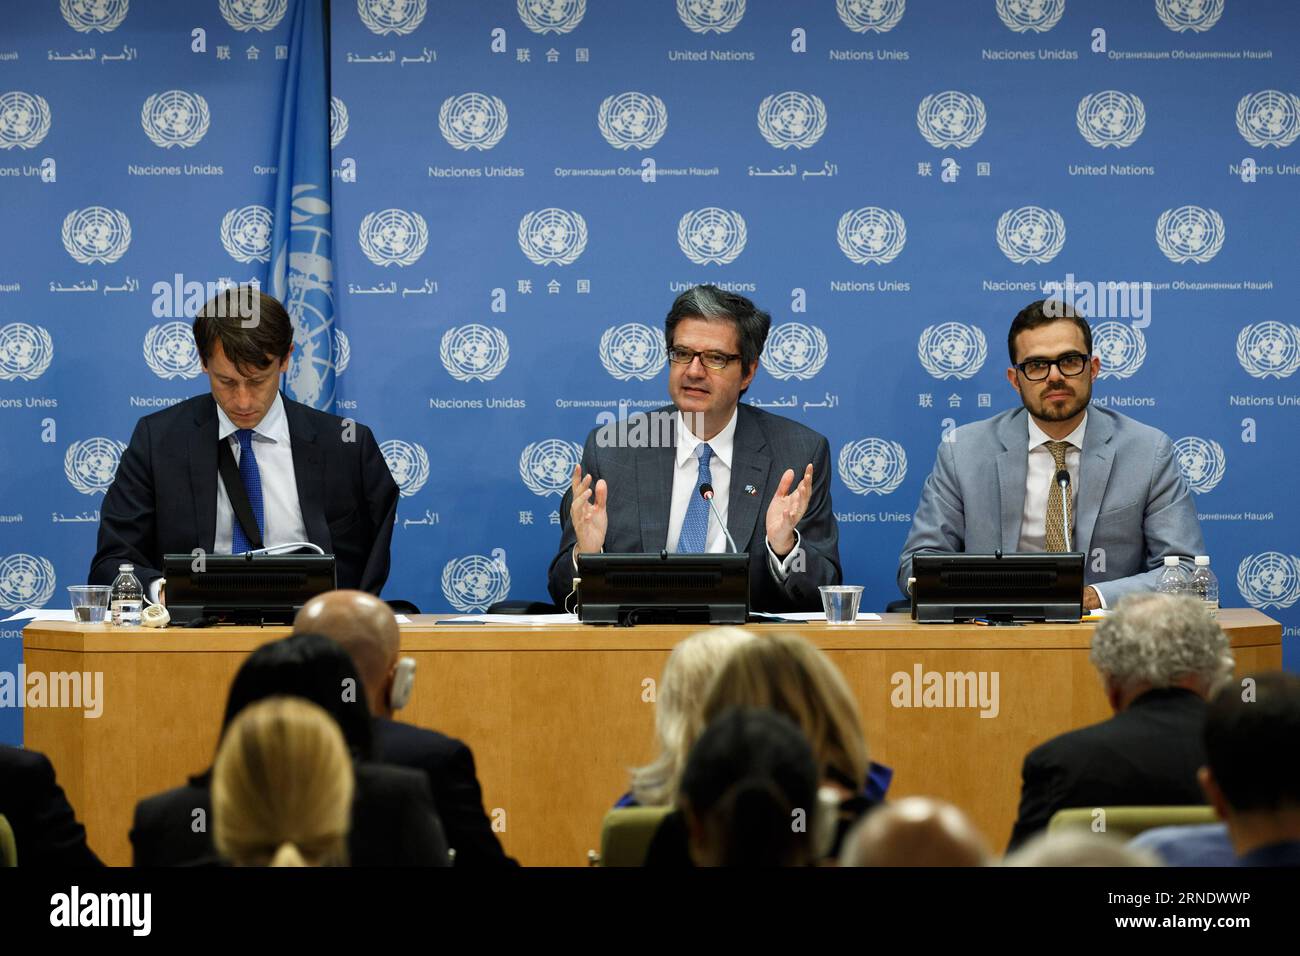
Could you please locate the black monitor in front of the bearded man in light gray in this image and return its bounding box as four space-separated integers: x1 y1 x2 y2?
911 551 1084 624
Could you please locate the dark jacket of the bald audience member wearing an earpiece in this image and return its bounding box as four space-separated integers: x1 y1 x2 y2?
373 718 517 866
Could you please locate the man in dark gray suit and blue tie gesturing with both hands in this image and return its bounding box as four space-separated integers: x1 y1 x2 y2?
549 285 841 611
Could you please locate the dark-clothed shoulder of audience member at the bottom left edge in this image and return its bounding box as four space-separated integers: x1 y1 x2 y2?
0 744 103 868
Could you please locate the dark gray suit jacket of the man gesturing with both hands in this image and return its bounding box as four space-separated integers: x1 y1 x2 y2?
547 405 841 613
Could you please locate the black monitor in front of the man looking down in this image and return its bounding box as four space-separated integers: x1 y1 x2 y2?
163 554 335 626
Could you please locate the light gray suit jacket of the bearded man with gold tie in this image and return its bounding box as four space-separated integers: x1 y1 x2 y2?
898 406 1205 607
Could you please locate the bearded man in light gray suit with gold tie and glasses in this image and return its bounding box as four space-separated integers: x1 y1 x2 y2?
898 299 1205 610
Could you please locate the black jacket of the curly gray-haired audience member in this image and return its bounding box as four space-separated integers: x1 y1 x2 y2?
1009 687 1206 849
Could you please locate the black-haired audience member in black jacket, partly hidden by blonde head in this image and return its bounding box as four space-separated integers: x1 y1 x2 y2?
131 635 449 866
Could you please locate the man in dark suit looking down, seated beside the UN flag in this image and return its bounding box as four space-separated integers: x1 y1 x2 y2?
90 287 398 600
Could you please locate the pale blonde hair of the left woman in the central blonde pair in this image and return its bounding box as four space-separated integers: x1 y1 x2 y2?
632 627 754 806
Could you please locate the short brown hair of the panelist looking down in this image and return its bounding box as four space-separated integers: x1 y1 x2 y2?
194 286 294 373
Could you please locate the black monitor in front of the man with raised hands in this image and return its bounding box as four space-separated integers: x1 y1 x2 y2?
575 551 749 627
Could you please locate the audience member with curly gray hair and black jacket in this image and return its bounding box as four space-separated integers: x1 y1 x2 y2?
1010 593 1232 849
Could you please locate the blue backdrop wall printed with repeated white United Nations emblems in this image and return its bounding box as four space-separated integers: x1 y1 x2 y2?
0 0 1300 740
